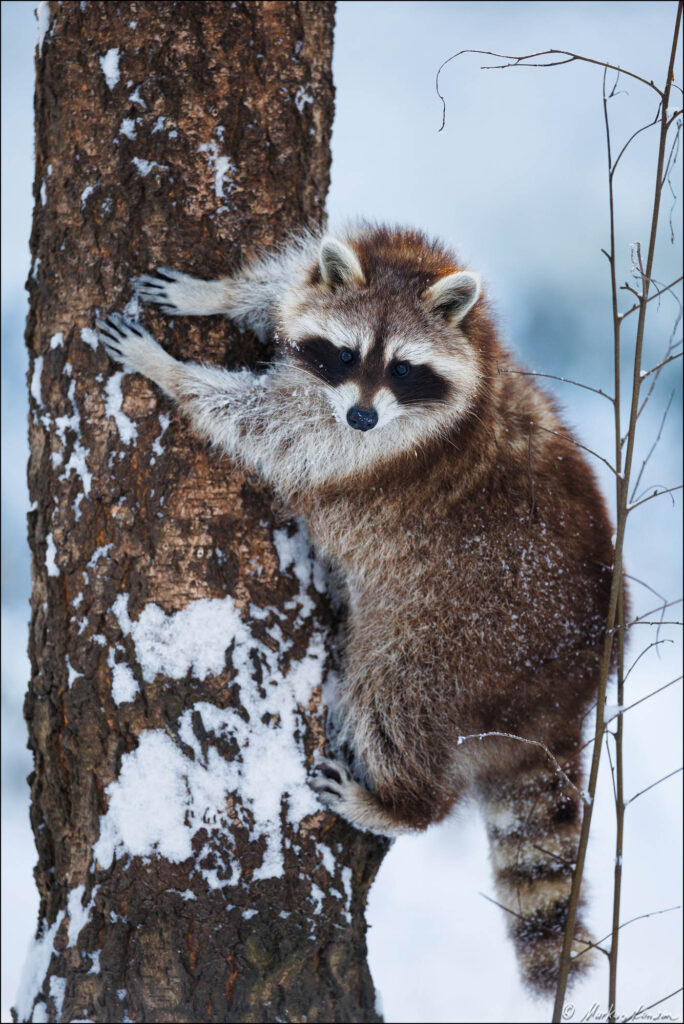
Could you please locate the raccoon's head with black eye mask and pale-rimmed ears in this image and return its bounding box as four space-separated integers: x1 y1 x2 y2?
281 234 481 440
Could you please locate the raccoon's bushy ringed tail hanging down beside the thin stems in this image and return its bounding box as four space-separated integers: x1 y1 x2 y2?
481 766 593 994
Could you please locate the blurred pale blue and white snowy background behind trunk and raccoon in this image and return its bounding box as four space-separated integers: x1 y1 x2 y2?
2 0 682 1022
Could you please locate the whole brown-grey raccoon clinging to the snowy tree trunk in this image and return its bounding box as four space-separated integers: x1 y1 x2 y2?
97 224 613 992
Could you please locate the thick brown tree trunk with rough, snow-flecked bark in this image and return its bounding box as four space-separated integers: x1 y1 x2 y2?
15 0 386 1021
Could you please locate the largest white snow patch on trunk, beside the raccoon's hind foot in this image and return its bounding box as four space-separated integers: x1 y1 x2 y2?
94 589 326 888
